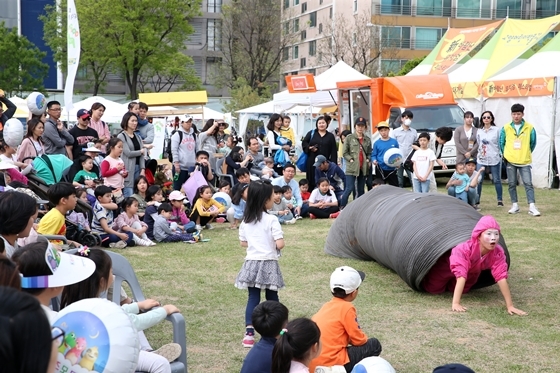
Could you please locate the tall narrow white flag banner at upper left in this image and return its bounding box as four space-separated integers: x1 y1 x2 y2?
64 0 80 112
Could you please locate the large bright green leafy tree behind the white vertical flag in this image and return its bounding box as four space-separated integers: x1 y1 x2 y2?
43 0 201 99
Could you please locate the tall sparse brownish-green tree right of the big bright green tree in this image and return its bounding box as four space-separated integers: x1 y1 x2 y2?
213 0 291 94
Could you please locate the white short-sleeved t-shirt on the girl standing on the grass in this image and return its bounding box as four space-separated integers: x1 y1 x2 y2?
239 212 284 260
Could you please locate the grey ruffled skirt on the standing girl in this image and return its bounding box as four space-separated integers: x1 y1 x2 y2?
235 260 285 291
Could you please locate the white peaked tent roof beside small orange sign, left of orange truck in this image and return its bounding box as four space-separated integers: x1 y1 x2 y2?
273 61 370 109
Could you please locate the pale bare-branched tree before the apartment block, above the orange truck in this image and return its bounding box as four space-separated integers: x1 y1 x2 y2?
317 12 398 77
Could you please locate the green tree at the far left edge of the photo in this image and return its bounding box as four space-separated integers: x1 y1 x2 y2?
0 22 49 96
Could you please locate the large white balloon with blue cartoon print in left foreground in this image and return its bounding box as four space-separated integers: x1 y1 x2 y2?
53 298 139 373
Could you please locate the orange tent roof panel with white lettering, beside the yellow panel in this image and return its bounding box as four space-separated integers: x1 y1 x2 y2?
430 21 503 74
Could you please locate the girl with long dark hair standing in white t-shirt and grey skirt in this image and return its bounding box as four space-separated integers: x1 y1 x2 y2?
235 181 284 348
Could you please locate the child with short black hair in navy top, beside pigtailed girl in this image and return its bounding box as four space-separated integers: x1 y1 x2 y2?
241 300 288 373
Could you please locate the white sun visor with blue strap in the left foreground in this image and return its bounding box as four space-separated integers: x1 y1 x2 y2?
21 242 95 289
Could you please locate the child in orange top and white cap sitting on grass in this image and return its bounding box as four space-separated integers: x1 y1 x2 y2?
309 266 381 372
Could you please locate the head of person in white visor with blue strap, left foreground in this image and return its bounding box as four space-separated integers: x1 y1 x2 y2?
12 241 95 324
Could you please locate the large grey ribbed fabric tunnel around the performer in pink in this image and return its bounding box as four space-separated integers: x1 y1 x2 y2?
325 185 509 291
